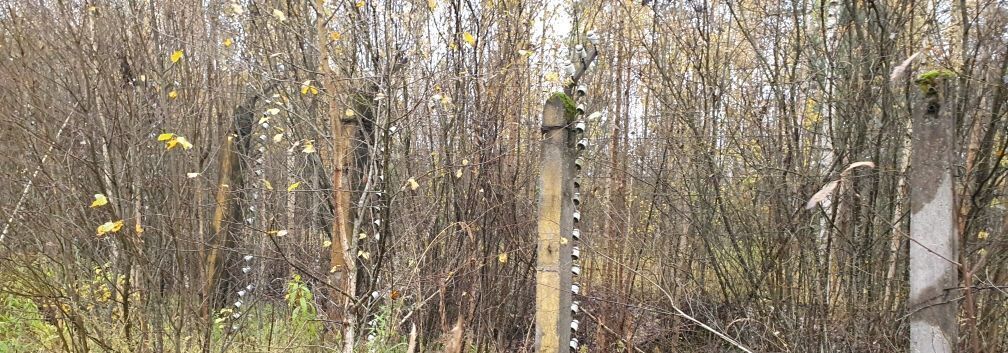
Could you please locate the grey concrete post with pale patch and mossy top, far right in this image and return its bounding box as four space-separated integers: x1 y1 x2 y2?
907 72 959 353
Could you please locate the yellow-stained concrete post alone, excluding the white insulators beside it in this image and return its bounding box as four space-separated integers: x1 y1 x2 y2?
535 94 575 353
